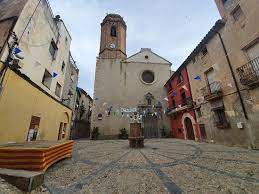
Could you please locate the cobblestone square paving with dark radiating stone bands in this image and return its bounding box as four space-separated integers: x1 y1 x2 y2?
0 139 259 194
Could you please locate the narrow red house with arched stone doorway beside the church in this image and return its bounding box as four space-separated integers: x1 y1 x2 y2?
165 66 201 141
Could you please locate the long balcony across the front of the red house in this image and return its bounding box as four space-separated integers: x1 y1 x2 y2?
166 98 193 115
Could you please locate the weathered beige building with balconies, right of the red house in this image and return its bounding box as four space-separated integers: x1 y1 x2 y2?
169 0 259 148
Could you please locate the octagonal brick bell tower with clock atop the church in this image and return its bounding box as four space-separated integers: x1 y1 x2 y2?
99 14 127 59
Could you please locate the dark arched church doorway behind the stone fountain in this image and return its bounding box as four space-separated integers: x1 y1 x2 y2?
143 114 159 138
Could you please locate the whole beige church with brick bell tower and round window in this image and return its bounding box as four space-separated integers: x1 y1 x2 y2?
92 14 172 138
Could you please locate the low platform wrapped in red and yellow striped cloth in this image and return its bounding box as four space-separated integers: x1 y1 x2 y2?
0 141 74 171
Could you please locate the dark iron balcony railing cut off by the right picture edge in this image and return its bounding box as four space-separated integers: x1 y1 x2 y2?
237 57 259 87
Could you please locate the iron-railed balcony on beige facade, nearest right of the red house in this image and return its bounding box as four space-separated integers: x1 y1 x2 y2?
201 81 223 101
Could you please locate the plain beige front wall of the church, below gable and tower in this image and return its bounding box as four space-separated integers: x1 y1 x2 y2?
92 55 170 135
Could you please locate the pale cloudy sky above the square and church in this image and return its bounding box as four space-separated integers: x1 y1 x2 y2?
49 0 220 96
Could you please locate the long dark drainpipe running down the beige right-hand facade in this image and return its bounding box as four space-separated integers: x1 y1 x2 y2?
214 31 249 120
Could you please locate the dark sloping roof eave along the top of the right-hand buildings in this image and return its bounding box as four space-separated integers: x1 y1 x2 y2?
165 20 225 86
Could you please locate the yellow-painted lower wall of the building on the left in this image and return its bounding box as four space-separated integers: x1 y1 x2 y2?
0 70 71 143
